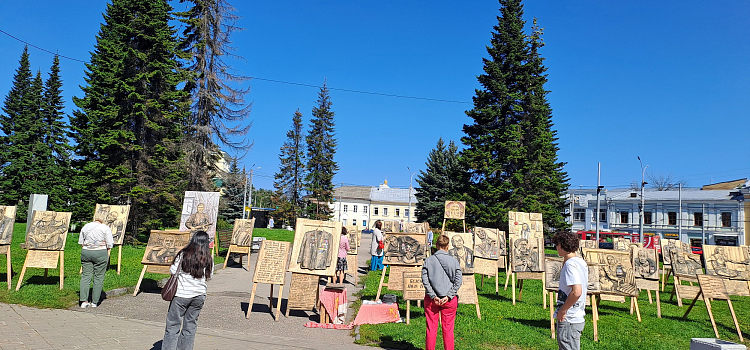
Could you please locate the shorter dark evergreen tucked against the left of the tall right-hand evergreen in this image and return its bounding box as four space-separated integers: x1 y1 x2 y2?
415 138 465 227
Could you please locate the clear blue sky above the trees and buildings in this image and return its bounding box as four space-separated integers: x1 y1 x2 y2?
0 0 750 193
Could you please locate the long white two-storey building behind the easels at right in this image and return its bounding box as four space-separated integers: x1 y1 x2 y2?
567 179 750 246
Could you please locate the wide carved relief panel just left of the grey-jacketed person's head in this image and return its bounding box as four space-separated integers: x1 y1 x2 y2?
383 232 427 266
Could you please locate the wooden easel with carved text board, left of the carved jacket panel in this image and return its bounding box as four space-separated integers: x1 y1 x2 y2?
245 240 291 321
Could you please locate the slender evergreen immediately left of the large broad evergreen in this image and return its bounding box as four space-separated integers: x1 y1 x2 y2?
39 55 71 211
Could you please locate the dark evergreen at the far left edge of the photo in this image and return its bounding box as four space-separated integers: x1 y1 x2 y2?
0 47 39 216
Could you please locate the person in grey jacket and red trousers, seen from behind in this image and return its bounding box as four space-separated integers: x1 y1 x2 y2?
422 235 462 350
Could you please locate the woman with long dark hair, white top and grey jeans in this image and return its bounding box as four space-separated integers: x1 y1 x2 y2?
161 231 214 350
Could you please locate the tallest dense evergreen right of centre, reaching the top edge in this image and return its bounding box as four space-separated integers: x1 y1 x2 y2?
461 0 568 229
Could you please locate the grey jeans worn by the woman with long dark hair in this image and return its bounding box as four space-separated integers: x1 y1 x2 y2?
161 294 206 350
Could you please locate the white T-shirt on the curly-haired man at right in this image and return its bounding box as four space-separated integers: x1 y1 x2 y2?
554 256 589 323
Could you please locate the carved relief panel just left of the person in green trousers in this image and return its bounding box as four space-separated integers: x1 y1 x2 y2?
26 211 71 250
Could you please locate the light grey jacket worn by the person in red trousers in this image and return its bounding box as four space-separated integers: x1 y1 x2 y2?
422 250 462 299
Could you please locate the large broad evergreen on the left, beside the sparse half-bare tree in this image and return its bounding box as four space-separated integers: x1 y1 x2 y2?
71 0 189 235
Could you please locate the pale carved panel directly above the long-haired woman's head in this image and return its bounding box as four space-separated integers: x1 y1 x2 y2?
180 191 221 242
